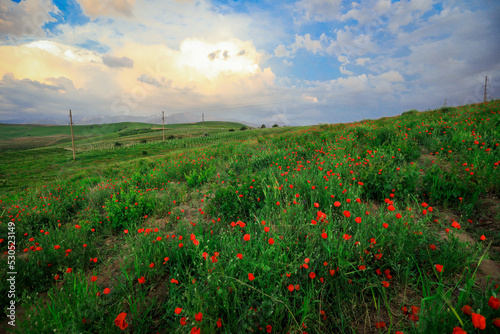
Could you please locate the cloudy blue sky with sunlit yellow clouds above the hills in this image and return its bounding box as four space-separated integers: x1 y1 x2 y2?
0 0 500 126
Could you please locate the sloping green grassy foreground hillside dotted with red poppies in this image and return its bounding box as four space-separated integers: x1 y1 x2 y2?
0 100 500 333
